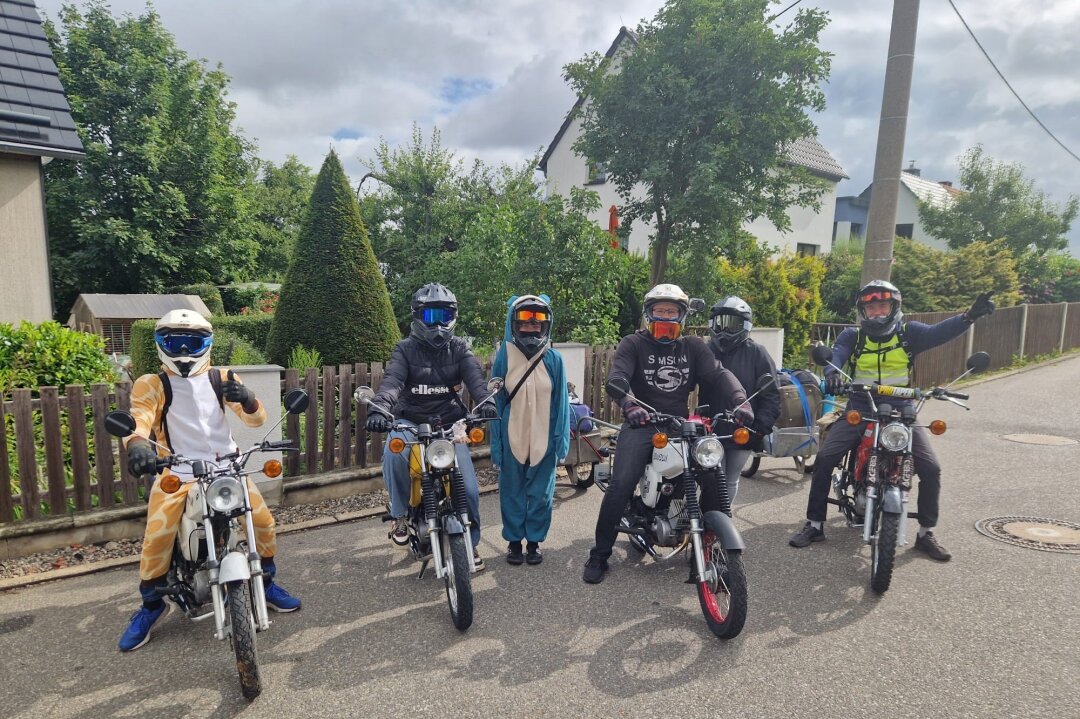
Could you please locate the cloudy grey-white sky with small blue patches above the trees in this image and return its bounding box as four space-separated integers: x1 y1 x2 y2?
38 0 1080 251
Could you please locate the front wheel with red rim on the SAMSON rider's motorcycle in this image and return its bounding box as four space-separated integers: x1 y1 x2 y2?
698 530 746 639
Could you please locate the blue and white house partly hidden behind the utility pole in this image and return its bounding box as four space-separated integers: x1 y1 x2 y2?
833 163 961 249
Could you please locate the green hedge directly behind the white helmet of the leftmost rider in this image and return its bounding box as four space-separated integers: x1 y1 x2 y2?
131 314 273 377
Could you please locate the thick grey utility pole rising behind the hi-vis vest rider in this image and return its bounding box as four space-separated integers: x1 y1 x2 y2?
862 0 919 284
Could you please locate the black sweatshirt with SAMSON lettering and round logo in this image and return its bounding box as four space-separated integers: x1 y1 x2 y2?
608 330 746 417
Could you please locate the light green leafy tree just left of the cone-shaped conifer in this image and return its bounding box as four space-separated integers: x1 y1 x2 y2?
252 154 315 282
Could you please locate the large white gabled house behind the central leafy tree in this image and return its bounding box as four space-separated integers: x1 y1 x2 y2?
540 27 848 255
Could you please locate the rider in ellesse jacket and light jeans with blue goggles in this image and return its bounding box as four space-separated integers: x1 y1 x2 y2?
366 283 497 571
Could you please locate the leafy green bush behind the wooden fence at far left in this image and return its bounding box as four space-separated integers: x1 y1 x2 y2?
0 322 114 394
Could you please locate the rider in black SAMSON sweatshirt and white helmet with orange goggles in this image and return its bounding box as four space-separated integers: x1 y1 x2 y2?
582 284 754 584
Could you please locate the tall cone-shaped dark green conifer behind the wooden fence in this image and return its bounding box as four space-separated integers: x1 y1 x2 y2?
268 151 400 365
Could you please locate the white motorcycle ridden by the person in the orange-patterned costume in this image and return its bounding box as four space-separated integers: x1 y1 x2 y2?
105 390 308 701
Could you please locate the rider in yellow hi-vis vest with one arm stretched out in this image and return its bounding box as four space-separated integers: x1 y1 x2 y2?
788 280 994 561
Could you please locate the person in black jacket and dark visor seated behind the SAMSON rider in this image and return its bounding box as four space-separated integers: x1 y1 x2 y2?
701 295 780 504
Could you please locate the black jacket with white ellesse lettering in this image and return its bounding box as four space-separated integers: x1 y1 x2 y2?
375 337 488 424
